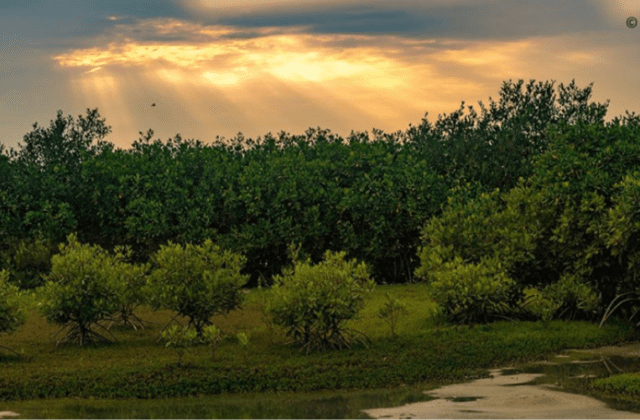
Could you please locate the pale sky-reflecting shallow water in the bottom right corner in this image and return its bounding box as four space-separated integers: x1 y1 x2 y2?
366 351 640 420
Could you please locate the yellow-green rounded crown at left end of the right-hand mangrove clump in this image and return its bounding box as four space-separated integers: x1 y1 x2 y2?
415 187 549 280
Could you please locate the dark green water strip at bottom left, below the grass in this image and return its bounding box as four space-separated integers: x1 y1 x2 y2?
7 388 433 420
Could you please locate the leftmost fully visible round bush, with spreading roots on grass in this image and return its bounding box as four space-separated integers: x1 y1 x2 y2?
40 234 124 346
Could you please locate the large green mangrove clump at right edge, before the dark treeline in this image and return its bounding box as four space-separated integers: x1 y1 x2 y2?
416 116 640 319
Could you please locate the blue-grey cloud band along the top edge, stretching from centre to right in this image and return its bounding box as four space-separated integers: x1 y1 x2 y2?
216 0 610 39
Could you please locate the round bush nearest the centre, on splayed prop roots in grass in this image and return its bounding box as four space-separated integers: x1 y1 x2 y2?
270 251 374 352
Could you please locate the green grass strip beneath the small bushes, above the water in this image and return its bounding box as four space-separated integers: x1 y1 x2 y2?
0 284 634 400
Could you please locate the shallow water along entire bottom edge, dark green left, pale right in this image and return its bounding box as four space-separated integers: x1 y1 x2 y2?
6 351 640 420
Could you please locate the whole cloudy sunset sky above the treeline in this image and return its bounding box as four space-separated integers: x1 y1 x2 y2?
0 0 640 149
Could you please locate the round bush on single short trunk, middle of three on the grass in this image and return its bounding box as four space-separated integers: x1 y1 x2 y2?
148 240 248 338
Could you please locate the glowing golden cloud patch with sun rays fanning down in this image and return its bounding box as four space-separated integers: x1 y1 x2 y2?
54 19 620 143
